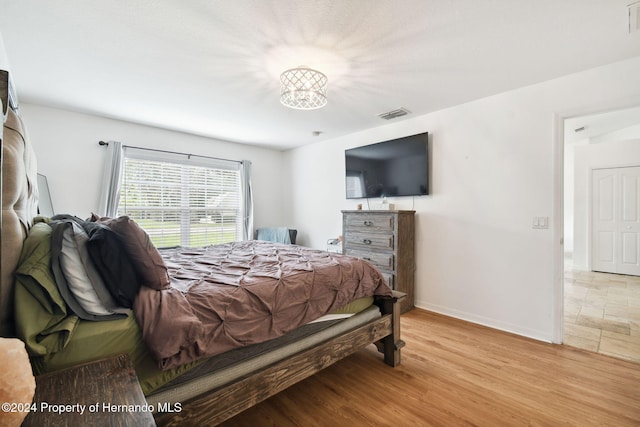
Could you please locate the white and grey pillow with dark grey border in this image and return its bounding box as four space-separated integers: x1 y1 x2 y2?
51 220 126 320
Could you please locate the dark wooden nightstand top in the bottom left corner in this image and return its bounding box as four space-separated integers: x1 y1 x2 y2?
22 354 156 427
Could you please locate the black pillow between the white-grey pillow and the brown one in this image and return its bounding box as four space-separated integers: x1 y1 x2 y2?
82 222 140 308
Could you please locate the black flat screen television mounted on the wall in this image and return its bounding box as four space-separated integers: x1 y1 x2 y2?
345 132 429 199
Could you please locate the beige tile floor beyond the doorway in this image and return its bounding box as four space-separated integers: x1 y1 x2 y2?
564 262 640 362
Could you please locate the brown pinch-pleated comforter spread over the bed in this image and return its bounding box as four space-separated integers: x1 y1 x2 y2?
134 241 391 369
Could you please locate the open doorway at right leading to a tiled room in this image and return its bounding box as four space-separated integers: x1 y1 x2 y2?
562 107 640 362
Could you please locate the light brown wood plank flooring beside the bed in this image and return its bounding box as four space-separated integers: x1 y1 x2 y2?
223 309 640 427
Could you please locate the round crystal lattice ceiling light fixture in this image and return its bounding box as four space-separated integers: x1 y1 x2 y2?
280 65 328 110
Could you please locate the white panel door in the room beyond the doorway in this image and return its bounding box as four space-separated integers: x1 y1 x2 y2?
591 167 640 276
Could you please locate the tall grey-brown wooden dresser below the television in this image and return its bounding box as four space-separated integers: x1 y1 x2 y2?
342 210 416 313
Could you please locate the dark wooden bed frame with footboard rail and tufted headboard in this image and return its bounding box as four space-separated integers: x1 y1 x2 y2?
0 70 404 426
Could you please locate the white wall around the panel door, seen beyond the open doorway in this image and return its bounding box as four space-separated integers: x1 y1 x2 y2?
573 139 640 270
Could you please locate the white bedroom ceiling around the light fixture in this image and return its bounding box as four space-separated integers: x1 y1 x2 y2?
0 0 640 149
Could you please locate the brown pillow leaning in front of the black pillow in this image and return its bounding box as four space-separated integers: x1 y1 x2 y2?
92 214 171 290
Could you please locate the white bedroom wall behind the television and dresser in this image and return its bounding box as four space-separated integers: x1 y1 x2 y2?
285 58 640 341
